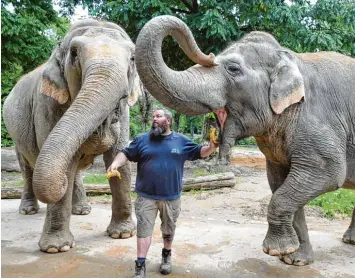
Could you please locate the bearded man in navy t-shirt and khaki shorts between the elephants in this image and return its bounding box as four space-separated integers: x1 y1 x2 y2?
107 109 217 277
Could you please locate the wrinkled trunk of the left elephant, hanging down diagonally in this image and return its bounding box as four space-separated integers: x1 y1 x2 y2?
33 61 128 204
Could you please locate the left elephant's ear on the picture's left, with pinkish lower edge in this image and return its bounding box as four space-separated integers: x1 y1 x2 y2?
40 47 70 104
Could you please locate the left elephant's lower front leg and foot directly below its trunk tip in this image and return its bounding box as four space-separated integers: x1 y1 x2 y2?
39 189 75 253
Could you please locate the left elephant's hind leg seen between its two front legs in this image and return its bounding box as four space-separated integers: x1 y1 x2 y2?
72 172 91 215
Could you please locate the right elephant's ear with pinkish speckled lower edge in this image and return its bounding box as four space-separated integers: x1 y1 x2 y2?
269 51 305 114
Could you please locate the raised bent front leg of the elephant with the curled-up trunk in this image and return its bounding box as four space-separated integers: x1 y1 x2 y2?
263 166 338 264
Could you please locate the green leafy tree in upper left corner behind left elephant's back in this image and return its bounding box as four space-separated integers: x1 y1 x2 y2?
1 0 69 146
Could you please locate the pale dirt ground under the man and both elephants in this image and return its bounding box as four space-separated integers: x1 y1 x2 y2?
1 149 355 278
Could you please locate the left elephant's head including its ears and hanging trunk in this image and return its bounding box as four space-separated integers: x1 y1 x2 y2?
33 20 139 203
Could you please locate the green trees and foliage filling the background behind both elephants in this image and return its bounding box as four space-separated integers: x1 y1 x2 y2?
1 0 355 146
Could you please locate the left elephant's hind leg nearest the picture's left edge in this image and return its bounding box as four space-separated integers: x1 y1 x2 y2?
16 148 39 215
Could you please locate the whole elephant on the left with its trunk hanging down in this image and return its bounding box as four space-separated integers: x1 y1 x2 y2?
4 20 139 253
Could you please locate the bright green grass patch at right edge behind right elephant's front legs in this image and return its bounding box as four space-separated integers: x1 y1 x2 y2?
309 189 355 218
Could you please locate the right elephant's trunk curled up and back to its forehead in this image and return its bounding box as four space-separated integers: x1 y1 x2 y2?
136 16 225 115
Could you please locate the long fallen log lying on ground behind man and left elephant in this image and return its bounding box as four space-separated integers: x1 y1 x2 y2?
1 172 236 199
